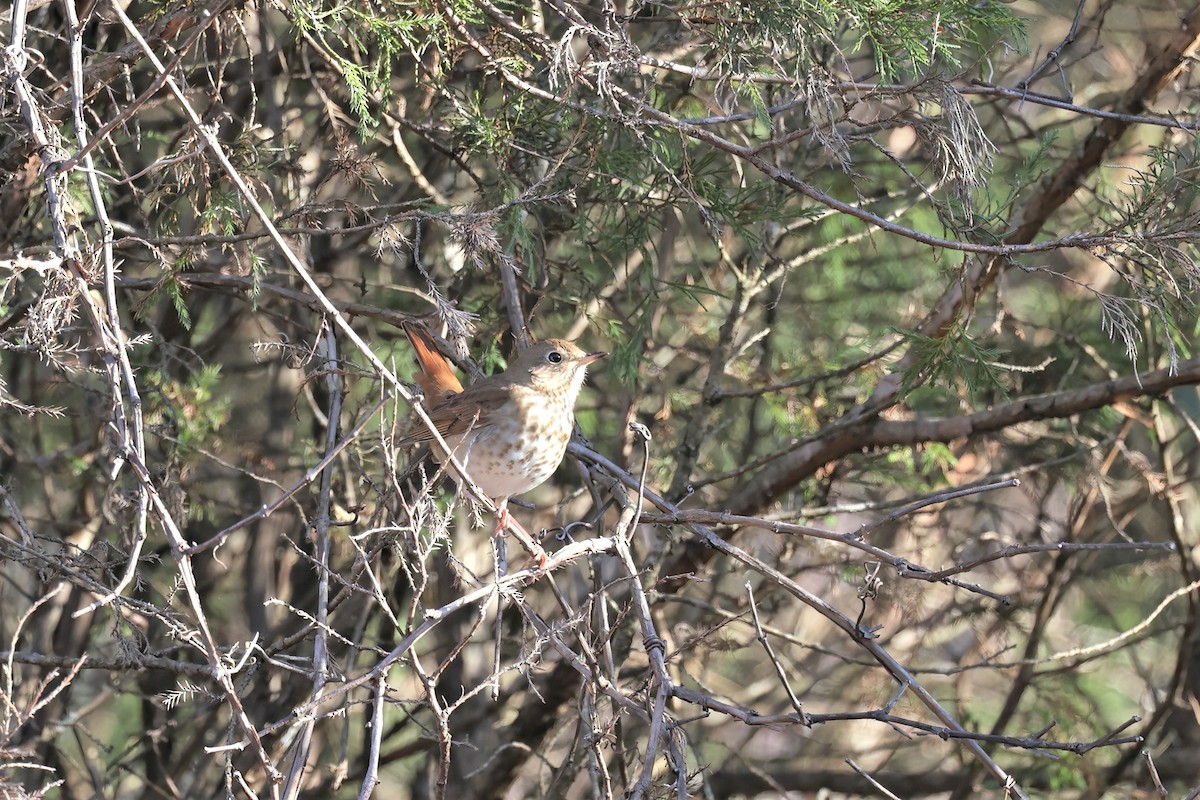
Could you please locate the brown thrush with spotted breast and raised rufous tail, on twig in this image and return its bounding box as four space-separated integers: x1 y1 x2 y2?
397 321 608 567
